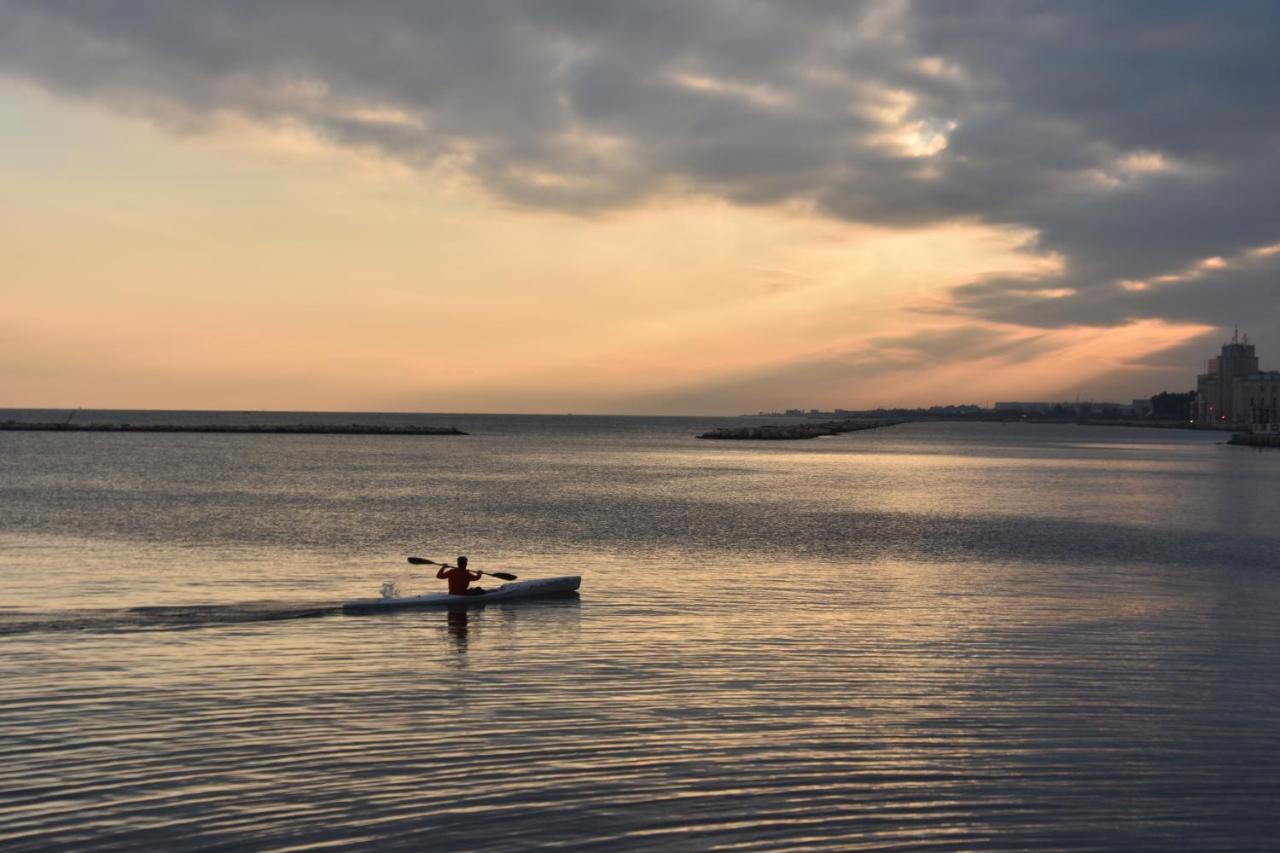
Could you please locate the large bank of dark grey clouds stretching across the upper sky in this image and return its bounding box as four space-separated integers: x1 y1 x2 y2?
0 0 1280 343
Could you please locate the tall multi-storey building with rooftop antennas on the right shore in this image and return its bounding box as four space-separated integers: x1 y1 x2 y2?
1196 334 1280 427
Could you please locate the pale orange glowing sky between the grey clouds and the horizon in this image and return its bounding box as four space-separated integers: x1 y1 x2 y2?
0 39 1221 414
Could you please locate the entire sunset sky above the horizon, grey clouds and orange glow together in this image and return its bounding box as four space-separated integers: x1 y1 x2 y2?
0 0 1280 414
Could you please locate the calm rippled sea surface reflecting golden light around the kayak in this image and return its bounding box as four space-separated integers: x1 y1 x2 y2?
0 412 1280 850
